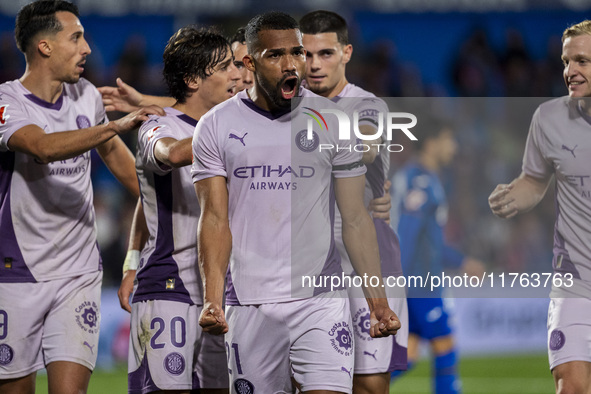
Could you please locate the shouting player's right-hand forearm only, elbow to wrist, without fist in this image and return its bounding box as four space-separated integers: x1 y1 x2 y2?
343 212 386 307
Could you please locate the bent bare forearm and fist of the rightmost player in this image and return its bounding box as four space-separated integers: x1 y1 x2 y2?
488 172 552 219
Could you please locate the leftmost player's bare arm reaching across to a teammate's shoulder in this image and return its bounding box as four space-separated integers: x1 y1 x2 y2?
8 106 164 164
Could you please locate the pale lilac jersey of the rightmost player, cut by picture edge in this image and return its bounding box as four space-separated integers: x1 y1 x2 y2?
523 96 591 297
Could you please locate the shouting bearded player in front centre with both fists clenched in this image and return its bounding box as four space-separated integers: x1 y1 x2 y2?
192 12 400 393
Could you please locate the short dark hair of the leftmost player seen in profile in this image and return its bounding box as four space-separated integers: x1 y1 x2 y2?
14 0 80 53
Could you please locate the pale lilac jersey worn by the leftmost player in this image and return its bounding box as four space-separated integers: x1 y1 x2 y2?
0 78 107 282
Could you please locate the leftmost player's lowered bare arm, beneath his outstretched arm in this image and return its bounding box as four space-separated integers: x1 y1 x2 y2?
96 137 140 198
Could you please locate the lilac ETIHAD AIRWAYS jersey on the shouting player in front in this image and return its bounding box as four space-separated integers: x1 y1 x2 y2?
192 89 365 305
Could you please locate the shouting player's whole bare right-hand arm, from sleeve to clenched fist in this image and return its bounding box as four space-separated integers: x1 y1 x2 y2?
335 176 400 337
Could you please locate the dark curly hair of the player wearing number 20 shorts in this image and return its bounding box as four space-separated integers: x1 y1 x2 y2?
162 26 231 103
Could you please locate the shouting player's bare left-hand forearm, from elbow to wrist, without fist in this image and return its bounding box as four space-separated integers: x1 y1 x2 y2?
198 213 232 305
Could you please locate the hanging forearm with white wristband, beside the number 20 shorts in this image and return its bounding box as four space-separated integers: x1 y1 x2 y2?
117 199 150 313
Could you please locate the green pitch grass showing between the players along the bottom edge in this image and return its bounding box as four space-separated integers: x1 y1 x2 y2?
36 354 554 394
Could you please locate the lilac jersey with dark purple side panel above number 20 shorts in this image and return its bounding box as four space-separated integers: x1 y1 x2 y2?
133 108 203 305
